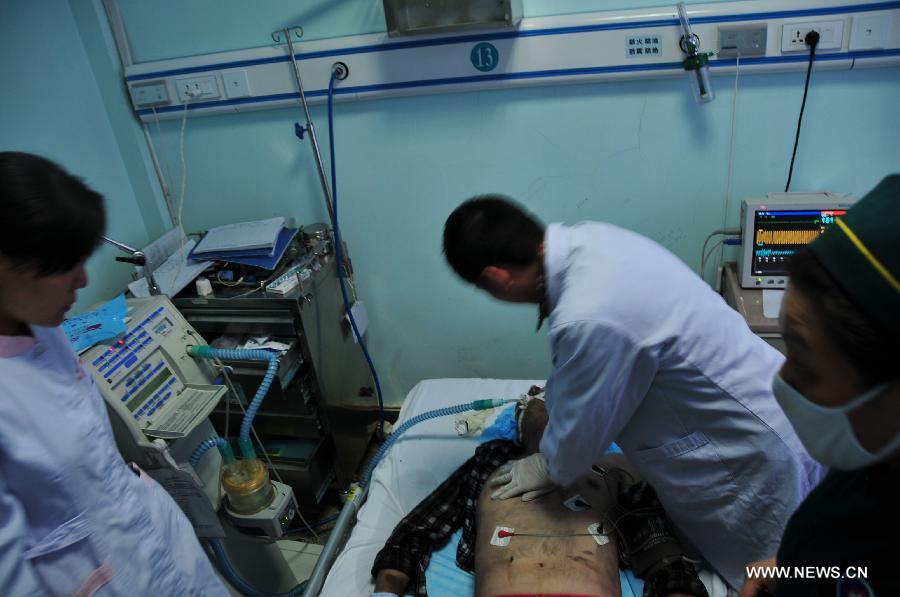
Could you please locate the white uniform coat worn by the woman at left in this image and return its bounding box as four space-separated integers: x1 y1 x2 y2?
0 326 228 597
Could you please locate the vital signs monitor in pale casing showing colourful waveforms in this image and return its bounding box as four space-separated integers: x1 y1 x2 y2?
739 193 856 289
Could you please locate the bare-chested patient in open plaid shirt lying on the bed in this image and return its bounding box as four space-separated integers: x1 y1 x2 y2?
372 392 706 597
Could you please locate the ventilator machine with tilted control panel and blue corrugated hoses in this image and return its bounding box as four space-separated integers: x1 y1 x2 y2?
81 296 298 590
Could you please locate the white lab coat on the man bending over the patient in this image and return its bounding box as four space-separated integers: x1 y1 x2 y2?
541 222 822 588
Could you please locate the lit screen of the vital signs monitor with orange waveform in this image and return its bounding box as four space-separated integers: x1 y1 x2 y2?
752 209 847 276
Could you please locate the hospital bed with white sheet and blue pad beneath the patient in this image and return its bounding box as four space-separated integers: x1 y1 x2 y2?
320 379 726 597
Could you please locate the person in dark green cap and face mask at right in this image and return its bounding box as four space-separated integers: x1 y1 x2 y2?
740 174 900 597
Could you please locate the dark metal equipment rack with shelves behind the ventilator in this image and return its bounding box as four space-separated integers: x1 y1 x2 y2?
173 228 378 511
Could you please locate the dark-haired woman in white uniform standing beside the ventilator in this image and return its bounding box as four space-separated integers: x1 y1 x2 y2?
0 152 228 597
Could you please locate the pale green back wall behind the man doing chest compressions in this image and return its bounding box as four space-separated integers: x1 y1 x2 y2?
10 0 900 404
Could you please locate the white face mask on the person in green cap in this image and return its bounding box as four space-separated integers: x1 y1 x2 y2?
772 375 900 471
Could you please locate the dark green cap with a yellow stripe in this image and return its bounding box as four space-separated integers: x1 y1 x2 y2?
810 174 900 338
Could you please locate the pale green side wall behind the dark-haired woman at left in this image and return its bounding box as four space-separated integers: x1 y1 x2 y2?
0 0 162 311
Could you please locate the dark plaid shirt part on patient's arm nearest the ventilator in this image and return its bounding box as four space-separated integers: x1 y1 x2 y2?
372 439 521 597
